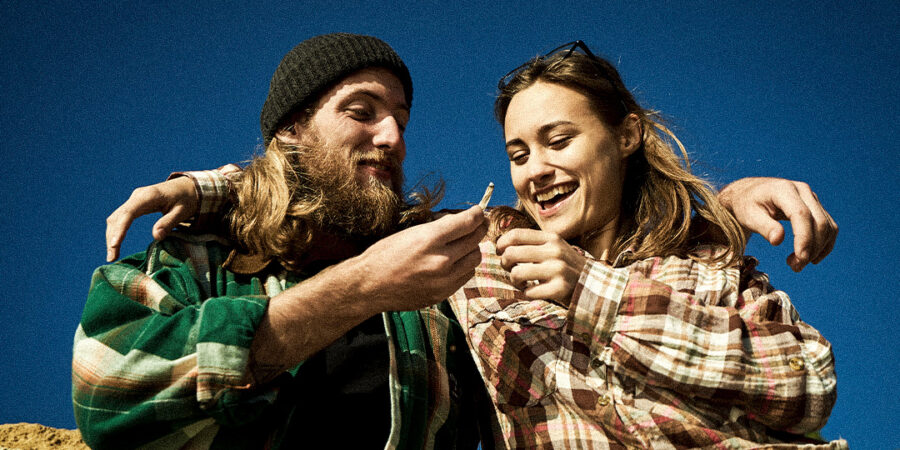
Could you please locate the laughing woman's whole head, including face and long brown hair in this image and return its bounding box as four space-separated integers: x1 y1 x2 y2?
495 41 744 268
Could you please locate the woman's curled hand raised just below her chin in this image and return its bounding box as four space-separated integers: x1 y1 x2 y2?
497 228 587 307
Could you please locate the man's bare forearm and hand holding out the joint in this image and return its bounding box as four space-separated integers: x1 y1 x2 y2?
251 206 487 381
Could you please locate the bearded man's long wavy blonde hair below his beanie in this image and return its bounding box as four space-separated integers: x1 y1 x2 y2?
228 129 436 270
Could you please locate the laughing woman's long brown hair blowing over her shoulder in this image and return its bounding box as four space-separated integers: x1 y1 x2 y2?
492 52 745 264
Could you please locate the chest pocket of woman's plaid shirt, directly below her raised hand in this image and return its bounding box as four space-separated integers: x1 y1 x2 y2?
463 274 566 410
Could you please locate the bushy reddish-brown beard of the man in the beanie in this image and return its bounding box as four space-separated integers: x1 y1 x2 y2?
297 141 403 242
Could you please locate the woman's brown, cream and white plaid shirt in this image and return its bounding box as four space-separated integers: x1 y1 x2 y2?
451 242 846 449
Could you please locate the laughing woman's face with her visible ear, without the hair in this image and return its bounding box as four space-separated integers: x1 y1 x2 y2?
503 82 640 255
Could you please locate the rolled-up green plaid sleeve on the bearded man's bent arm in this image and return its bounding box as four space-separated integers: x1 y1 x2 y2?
72 238 277 448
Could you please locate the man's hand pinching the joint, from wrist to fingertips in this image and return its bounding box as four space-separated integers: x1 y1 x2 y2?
358 205 487 311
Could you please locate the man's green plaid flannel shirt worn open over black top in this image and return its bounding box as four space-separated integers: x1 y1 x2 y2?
72 232 483 449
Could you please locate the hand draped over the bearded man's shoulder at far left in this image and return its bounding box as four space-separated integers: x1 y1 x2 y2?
106 177 199 262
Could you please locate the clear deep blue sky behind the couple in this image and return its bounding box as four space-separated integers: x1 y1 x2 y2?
0 0 900 449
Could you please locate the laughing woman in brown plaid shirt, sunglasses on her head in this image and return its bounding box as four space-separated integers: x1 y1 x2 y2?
451 41 840 448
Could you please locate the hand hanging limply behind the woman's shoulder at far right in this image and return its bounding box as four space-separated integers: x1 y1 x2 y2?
719 177 838 272
